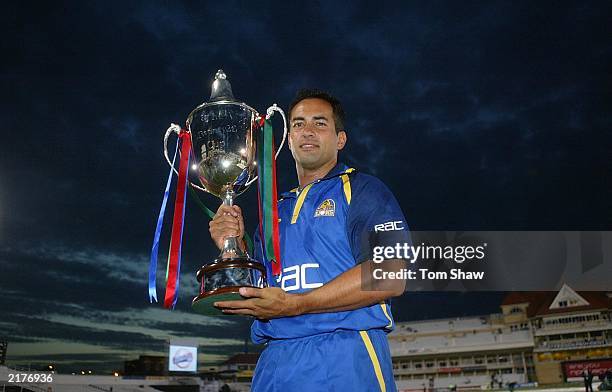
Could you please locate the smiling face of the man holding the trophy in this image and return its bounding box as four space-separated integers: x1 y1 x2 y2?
289 98 346 170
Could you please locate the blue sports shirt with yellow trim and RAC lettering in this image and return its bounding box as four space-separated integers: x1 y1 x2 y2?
251 163 409 344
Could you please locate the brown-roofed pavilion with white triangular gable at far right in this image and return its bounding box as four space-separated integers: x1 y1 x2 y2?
502 286 612 384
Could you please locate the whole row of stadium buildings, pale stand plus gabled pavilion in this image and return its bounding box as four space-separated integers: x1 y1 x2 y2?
389 285 612 391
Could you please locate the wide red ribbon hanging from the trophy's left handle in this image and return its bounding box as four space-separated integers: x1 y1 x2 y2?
164 130 191 308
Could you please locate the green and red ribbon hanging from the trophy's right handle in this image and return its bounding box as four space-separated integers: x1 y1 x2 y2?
257 119 284 276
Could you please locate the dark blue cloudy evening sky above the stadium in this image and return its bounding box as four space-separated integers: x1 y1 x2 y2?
0 1 612 371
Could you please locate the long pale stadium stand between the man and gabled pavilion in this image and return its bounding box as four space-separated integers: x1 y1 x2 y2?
389 315 535 390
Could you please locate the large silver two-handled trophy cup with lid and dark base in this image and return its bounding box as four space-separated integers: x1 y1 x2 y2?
164 70 284 315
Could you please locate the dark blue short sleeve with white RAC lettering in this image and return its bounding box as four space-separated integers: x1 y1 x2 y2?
346 173 410 263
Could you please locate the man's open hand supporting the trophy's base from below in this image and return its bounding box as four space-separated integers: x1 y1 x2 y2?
214 287 300 320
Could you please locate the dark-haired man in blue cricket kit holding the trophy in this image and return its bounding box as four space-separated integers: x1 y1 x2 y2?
210 90 409 391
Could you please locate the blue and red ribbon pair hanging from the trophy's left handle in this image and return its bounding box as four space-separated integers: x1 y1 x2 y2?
149 125 191 308
